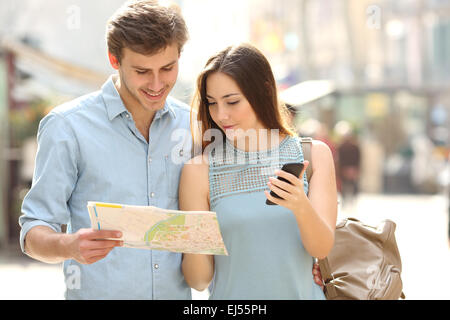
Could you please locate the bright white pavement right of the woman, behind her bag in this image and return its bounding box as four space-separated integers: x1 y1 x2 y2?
338 195 450 300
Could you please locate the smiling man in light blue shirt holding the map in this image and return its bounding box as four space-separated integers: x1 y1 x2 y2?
19 1 191 299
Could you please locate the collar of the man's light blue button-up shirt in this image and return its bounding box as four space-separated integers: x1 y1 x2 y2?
102 75 176 121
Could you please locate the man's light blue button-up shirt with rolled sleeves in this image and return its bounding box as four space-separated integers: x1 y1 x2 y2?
19 77 192 299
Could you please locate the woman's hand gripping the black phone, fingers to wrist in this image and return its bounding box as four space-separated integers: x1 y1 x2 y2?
264 160 309 212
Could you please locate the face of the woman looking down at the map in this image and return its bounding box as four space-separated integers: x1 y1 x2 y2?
206 72 265 140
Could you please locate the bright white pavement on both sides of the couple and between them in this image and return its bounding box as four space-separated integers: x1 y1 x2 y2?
0 194 450 300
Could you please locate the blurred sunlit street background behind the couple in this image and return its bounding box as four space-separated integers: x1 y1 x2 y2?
0 0 450 299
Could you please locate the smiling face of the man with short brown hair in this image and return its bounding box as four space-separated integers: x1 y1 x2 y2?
112 44 179 112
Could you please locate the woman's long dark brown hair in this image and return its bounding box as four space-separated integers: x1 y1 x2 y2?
191 44 295 151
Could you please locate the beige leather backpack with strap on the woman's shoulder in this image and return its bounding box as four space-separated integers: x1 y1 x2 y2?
302 138 405 300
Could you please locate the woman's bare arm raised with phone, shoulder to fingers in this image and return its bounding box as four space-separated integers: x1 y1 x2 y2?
265 141 337 259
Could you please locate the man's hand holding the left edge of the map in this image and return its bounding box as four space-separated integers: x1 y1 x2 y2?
68 229 123 264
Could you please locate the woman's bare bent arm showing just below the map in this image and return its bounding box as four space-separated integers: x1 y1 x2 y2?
181 253 214 291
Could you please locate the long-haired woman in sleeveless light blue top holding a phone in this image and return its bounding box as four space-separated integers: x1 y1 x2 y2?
179 44 337 299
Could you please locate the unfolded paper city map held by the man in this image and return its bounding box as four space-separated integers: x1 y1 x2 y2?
87 201 228 255
